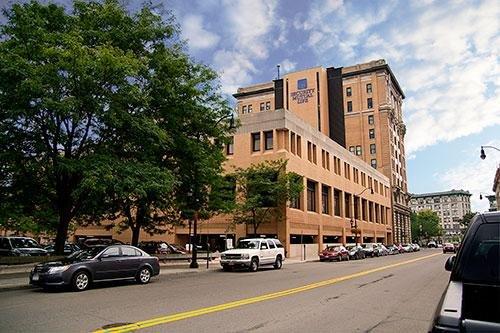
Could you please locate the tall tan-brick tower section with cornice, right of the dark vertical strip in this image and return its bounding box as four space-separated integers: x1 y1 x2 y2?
342 60 411 243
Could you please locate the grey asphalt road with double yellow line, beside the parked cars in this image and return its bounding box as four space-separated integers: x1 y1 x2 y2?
0 250 449 332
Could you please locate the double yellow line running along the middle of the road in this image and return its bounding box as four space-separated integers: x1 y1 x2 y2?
94 253 440 333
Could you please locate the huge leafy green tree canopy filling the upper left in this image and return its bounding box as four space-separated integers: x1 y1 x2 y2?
0 0 231 249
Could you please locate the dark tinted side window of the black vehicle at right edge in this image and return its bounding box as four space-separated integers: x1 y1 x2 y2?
463 223 500 284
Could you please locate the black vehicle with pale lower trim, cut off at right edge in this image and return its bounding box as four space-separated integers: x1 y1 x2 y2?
429 212 500 333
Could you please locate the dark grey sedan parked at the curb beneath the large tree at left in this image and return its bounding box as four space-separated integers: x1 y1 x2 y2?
30 245 160 291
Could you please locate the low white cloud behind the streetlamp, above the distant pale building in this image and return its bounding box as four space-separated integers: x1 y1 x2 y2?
438 141 500 212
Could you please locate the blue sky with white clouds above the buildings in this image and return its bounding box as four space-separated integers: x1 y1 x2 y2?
0 0 500 211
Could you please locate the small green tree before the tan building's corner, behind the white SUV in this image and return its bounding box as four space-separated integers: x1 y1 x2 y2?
233 160 304 235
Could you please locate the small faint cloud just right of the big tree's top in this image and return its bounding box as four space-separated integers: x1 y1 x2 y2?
182 15 220 50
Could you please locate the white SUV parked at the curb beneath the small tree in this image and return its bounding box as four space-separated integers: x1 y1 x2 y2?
220 238 285 272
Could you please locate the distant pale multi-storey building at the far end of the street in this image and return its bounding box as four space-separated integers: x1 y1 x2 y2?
410 190 472 241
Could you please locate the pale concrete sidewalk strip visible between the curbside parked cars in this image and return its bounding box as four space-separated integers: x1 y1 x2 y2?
0 258 317 292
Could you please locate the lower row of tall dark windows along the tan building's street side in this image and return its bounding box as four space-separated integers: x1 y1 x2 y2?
290 179 389 224
